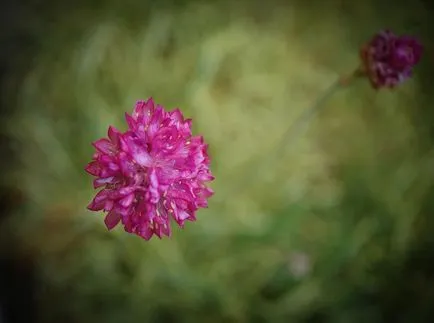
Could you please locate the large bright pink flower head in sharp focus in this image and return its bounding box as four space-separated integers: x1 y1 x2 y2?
86 98 214 240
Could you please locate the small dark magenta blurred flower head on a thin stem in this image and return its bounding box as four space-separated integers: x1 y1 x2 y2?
360 30 422 89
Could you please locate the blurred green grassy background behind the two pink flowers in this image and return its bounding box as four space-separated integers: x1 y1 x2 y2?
0 0 434 323
